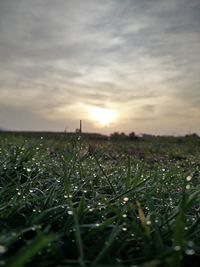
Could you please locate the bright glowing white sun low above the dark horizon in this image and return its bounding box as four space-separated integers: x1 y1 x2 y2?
89 107 116 126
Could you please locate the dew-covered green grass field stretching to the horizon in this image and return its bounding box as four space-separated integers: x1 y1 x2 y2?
0 133 200 267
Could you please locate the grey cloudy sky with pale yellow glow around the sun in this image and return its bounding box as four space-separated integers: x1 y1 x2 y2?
0 0 200 135
